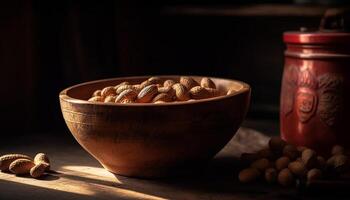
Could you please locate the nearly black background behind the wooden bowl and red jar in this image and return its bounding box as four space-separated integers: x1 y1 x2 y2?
0 0 345 136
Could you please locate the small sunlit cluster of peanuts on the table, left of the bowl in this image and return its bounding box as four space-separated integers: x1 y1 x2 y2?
0 153 50 178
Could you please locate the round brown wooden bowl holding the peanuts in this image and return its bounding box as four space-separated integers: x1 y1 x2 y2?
59 76 250 178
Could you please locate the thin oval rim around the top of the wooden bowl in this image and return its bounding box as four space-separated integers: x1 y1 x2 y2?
59 75 251 106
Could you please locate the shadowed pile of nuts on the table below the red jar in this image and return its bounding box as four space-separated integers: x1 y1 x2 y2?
238 137 350 186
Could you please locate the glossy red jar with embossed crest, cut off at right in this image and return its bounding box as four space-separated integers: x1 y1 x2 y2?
280 31 350 152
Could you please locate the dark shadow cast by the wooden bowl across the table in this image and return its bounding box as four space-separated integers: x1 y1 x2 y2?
116 157 282 199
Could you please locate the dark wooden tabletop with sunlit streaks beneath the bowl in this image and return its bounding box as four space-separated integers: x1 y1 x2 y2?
0 120 342 200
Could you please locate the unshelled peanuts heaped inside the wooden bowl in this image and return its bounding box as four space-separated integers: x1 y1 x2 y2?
89 76 236 104
